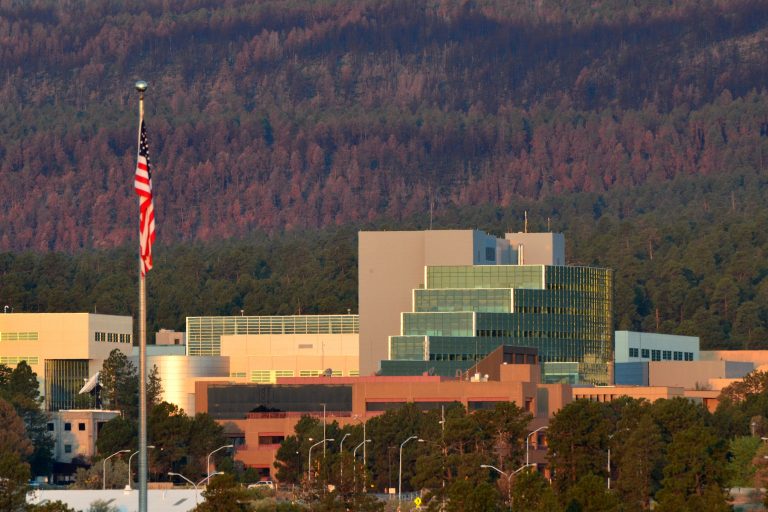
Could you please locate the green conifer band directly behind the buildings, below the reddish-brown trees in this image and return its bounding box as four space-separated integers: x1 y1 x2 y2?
0 166 768 348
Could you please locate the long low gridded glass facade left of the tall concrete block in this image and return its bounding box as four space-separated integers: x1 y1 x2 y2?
187 314 360 356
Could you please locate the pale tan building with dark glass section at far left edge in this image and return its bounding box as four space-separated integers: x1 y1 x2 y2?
0 313 133 411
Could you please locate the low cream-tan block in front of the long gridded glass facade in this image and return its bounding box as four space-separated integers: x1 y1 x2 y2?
221 333 360 384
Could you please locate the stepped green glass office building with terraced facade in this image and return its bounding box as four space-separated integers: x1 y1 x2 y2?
381 265 613 384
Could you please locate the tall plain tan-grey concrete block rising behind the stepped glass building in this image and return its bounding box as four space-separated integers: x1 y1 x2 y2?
358 230 565 375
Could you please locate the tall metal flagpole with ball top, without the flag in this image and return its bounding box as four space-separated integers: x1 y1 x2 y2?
136 81 147 512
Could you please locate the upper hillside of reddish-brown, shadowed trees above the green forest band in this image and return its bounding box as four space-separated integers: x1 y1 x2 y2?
0 0 768 252
